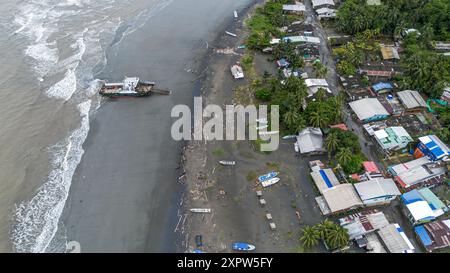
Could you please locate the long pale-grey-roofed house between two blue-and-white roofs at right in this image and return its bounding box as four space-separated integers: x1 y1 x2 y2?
388 157 445 191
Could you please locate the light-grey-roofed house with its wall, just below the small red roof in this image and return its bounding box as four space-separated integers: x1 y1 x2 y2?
354 178 400 206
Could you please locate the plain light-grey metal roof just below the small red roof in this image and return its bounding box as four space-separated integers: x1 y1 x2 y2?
354 178 401 201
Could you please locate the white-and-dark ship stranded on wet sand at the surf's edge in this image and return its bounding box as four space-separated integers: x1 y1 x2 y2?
99 77 170 97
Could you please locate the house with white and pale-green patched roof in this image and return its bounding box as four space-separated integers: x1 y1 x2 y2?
374 126 413 153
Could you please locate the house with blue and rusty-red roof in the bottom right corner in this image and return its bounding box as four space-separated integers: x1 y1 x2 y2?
414 219 450 252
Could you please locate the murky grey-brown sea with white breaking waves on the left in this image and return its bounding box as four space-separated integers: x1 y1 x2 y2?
0 0 172 252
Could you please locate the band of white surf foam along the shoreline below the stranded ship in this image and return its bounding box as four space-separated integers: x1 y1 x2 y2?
12 100 91 252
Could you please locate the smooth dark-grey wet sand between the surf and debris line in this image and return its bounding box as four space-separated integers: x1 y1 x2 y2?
60 0 256 252
